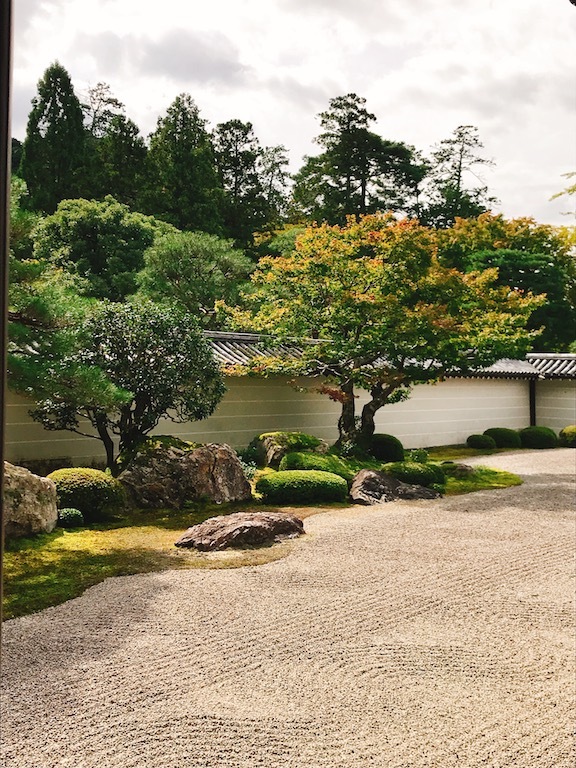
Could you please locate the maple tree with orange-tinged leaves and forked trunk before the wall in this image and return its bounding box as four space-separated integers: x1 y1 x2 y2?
226 214 542 445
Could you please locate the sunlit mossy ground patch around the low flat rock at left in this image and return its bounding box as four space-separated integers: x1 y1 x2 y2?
3 505 291 619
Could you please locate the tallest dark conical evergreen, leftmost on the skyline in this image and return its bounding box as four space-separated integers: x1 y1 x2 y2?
20 62 87 213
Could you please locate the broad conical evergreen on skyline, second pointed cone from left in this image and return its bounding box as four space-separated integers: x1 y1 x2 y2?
142 93 223 234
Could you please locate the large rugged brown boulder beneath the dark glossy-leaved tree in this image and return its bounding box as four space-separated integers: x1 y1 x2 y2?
118 443 252 509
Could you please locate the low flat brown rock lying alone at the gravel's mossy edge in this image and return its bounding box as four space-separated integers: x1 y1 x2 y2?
175 512 304 552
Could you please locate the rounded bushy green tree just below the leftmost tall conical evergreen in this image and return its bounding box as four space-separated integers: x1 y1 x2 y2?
34 196 170 301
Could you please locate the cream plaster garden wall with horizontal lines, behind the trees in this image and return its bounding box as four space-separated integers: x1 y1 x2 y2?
6 377 532 465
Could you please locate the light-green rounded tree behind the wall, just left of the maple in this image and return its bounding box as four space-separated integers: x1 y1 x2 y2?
137 226 253 328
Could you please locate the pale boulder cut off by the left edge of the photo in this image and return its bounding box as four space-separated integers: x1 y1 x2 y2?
4 461 58 538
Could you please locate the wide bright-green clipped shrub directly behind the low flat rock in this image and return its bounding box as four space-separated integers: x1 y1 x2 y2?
256 469 348 504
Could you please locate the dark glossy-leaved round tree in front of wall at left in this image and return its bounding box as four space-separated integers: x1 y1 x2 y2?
32 302 225 472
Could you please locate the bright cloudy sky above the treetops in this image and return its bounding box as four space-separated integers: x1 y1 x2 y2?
13 0 576 224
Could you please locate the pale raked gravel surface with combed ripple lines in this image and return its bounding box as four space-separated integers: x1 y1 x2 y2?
0 449 576 768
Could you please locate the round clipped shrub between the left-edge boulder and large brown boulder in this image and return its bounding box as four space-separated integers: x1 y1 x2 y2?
48 467 124 523
